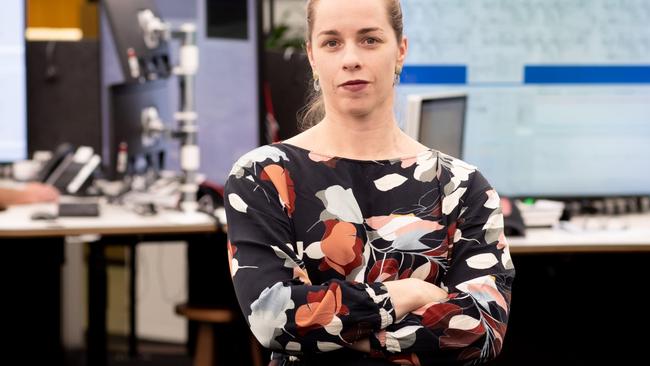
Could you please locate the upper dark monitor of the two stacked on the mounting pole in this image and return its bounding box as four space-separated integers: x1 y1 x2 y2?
103 0 171 82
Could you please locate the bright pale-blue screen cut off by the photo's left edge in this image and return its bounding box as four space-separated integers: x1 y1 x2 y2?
0 0 27 163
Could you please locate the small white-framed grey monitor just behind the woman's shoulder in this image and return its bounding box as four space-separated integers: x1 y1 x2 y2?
404 93 467 158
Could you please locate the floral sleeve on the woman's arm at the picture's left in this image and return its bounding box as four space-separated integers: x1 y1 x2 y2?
225 153 394 354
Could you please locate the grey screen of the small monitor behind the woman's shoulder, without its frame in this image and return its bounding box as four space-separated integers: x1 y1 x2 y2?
418 96 467 158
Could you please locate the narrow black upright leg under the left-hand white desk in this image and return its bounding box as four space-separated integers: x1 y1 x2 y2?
87 243 108 366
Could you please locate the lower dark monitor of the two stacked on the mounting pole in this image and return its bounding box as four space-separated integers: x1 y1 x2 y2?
104 80 173 179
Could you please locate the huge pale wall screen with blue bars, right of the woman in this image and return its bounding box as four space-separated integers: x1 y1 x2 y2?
398 0 650 197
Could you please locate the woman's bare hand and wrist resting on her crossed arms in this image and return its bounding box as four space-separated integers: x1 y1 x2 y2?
384 278 447 319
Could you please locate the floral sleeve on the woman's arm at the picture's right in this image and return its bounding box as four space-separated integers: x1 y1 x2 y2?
370 170 514 365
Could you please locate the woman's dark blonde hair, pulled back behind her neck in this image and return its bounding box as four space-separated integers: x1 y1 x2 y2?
298 0 404 130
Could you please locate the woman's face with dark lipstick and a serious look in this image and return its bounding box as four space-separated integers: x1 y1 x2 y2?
307 0 407 117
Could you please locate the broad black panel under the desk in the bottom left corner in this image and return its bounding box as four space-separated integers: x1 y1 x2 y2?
0 238 65 366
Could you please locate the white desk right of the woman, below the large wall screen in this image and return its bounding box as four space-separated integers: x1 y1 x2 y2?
508 214 650 254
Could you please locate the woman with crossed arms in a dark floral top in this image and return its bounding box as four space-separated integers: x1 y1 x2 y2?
226 0 514 365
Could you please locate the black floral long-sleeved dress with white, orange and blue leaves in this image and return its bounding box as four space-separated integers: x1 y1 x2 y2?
225 144 514 366
